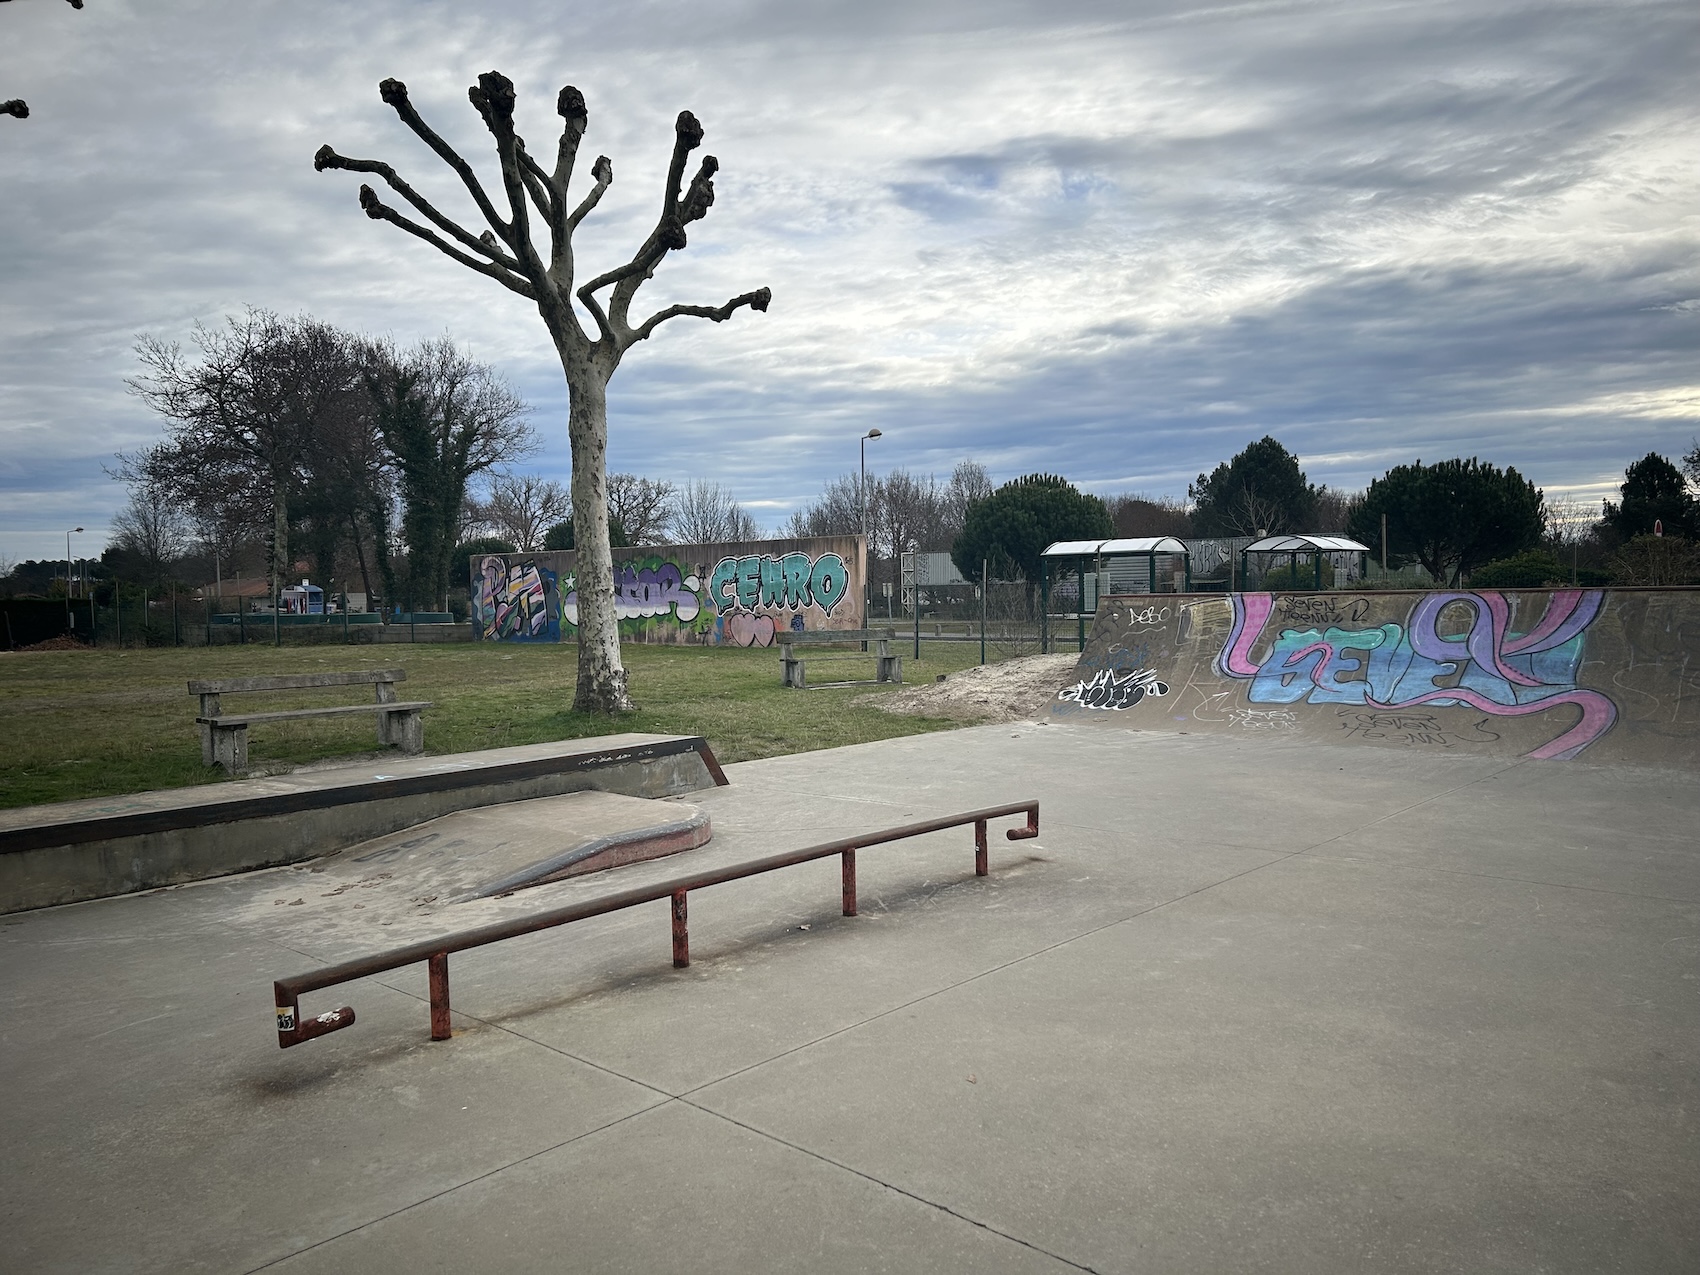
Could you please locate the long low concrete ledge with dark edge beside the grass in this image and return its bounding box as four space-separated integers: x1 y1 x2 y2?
0 734 726 913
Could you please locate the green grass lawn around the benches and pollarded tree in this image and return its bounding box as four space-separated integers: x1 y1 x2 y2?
0 641 996 808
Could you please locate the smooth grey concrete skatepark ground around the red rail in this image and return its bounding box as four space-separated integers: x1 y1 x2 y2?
0 723 1700 1275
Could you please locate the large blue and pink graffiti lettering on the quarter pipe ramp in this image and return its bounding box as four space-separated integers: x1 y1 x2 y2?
1216 590 1617 758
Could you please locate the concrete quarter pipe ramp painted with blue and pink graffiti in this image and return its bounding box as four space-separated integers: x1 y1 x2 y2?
1052 588 1700 768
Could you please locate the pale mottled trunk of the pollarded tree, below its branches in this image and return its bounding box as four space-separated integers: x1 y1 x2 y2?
561 357 634 712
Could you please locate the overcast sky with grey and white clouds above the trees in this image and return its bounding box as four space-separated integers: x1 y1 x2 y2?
0 0 1700 559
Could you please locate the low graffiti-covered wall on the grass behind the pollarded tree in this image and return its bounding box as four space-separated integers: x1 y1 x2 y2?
473 536 865 646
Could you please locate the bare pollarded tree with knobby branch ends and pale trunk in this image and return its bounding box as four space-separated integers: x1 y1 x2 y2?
313 71 770 712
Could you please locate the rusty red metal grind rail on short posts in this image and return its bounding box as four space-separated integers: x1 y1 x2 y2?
272 801 1039 1049
